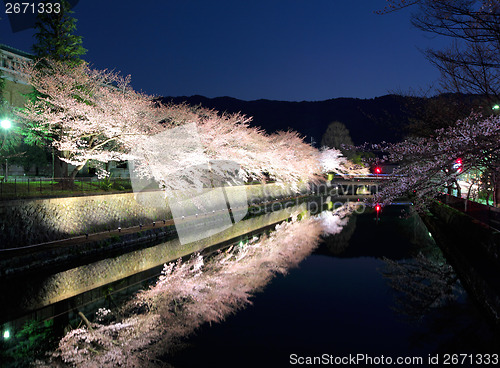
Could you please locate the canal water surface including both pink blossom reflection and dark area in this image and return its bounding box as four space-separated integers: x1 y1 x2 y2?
30 207 499 367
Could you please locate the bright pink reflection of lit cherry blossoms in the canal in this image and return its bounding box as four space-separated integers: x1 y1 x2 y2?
46 205 355 367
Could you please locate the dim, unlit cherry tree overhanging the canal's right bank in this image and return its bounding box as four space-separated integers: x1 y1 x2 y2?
373 114 500 206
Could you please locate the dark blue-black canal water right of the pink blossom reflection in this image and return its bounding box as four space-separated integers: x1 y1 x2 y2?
165 206 500 368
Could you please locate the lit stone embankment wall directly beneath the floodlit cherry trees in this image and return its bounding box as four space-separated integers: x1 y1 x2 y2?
0 184 307 249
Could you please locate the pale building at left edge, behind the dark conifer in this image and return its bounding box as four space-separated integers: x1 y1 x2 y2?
0 44 33 107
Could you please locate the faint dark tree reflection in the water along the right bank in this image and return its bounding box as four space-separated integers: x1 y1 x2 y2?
383 251 500 353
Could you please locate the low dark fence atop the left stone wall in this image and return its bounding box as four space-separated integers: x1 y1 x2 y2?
0 176 132 200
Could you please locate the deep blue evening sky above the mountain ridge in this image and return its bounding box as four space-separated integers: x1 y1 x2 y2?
0 0 450 101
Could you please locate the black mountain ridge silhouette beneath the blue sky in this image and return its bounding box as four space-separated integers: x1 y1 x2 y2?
158 95 410 146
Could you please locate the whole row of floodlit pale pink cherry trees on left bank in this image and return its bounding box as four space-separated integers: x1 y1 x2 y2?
20 61 364 189
